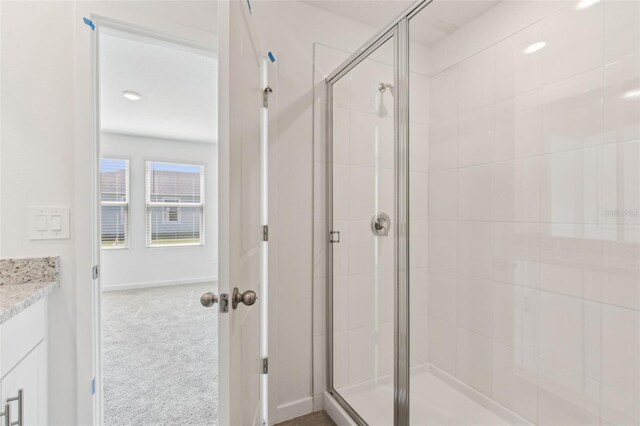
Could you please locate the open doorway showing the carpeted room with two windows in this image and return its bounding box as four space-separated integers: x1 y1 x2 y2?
97 22 218 425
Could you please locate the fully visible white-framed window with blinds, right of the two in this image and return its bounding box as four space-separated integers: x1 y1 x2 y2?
146 161 204 247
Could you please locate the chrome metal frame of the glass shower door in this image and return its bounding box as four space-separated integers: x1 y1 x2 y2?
325 0 433 426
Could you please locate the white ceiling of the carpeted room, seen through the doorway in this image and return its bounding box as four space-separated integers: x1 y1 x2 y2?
100 29 218 143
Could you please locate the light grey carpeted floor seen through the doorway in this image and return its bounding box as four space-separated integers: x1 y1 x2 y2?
102 284 218 426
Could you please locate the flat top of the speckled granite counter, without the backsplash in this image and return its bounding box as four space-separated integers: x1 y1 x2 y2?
0 281 60 324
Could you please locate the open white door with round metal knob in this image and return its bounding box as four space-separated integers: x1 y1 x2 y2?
218 0 268 426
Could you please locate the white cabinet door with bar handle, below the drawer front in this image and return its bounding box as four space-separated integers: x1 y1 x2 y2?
0 341 47 426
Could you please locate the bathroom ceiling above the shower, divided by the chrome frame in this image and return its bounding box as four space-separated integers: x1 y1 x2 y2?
302 0 500 46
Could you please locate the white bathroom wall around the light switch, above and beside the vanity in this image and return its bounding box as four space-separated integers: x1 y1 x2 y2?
0 1 77 425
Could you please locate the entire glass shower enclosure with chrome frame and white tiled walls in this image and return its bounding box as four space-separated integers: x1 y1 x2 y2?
323 0 640 425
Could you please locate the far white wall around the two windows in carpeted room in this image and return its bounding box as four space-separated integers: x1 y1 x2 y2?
100 133 218 290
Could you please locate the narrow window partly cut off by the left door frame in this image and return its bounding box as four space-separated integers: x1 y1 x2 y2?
100 158 129 248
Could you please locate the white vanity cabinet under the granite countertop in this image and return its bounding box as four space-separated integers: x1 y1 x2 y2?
0 298 48 426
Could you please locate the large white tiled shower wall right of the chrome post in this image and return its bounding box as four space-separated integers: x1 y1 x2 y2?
420 0 640 424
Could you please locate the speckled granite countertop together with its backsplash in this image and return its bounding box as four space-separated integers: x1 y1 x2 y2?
0 257 60 324
